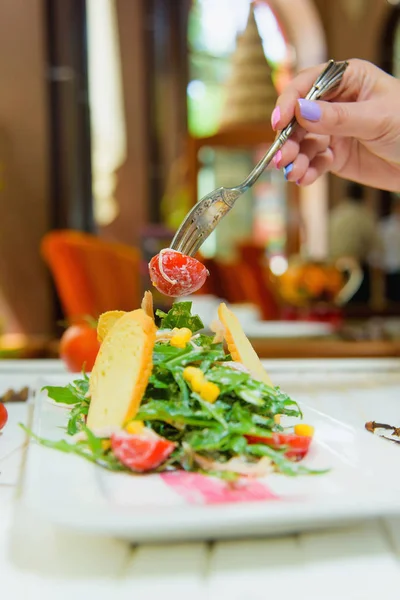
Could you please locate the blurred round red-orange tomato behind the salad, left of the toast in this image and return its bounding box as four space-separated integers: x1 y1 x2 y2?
60 324 100 373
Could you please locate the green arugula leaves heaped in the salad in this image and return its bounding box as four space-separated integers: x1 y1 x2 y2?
28 302 325 480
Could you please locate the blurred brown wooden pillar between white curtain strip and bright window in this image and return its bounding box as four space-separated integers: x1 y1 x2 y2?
102 0 190 245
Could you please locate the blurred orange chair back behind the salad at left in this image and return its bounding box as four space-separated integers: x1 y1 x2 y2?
41 230 141 320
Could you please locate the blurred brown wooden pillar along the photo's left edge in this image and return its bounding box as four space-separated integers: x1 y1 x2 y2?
0 0 52 333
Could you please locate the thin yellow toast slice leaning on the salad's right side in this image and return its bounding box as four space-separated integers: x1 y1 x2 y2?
218 303 273 387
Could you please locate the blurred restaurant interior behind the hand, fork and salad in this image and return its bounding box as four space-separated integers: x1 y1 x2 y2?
0 0 400 356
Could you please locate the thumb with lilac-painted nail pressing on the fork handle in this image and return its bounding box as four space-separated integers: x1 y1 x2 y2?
295 99 383 140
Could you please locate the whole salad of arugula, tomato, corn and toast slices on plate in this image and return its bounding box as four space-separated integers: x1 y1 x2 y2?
25 292 322 482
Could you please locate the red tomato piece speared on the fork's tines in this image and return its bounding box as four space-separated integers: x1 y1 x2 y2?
149 248 209 298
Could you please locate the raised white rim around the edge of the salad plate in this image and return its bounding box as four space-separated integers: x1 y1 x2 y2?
19 374 400 542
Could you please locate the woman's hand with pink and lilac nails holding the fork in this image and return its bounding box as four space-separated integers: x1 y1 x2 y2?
272 59 400 192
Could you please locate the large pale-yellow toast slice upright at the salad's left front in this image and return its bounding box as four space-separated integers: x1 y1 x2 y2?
87 309 156 429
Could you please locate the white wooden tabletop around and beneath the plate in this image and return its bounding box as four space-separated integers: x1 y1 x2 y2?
0 359 400 600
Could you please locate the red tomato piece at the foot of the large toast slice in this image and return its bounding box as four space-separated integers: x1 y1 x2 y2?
111 432 175 473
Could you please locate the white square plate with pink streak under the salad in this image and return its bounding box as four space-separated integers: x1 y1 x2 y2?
22 378 400 542
